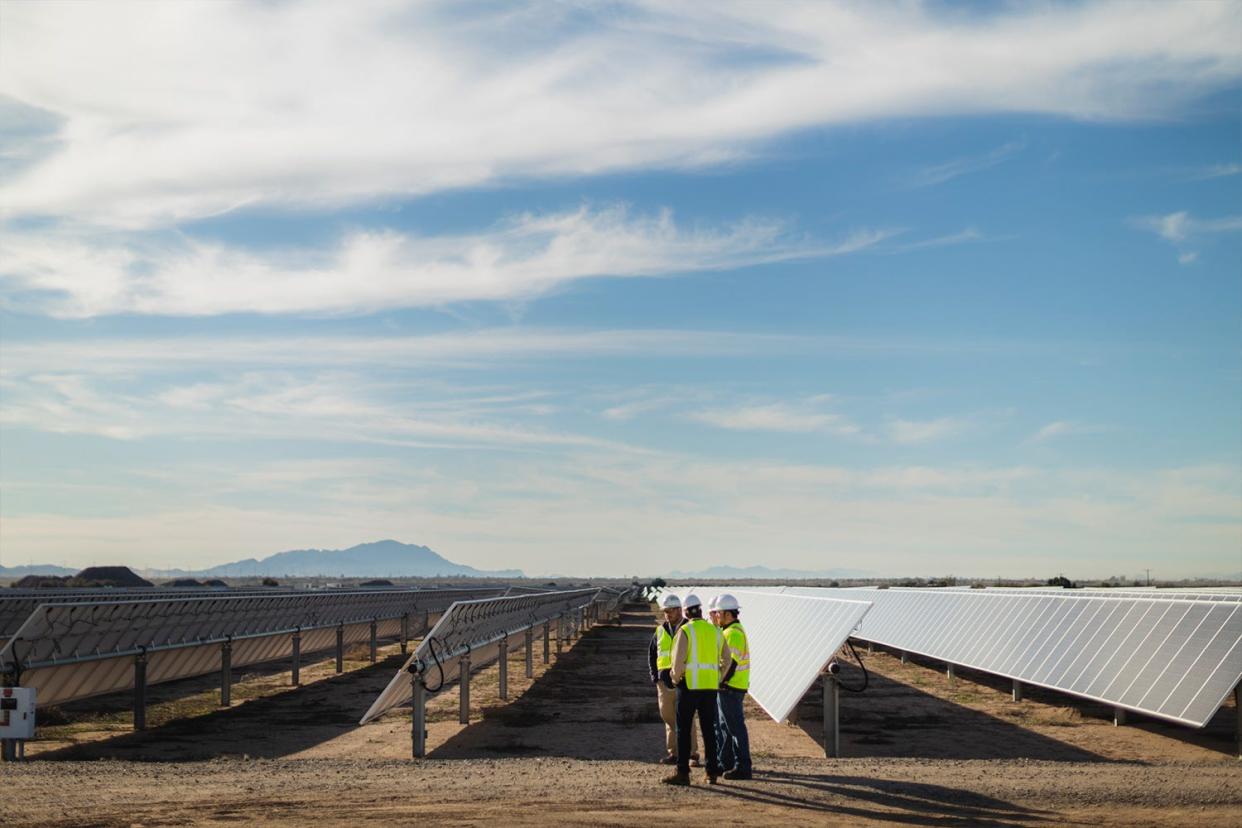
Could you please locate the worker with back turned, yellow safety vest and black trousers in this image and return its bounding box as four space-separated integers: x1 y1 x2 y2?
662 593 733 785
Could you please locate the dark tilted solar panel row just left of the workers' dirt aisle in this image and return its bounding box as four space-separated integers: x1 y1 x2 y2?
359 587 599 724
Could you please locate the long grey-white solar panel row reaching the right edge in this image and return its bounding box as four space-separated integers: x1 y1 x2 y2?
786 587 1242 727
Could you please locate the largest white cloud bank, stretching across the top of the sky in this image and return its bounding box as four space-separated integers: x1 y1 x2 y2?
0 0 1242 227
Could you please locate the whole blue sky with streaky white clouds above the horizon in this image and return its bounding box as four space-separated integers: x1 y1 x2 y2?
0 0 1242 578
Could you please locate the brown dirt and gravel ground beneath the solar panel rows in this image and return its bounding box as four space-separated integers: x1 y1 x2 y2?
0 607 1242 826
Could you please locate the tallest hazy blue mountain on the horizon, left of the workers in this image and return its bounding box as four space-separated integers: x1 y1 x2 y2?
164 540 523 577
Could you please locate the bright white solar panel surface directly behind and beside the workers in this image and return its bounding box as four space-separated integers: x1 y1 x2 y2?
673 586 871 721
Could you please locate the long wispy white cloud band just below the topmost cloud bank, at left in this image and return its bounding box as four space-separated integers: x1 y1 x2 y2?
0 207 889 318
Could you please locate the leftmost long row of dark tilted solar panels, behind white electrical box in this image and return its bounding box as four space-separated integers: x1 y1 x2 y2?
0 588 498 704
